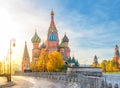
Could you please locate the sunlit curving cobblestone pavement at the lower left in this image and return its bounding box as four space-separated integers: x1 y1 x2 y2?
7 76 67 88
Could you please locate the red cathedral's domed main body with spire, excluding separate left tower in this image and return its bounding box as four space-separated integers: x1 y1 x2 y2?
31 11 70 63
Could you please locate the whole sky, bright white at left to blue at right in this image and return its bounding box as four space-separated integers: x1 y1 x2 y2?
0 0 120 64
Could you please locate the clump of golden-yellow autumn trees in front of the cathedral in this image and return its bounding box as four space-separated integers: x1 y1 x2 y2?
31 50 64 72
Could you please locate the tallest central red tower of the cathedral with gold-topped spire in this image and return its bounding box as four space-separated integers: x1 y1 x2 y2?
46 11 59 52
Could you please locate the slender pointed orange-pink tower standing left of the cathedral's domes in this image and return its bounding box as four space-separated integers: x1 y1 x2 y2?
22 42 30 72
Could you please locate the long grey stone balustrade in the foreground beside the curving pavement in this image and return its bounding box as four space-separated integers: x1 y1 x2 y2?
16 72 119 88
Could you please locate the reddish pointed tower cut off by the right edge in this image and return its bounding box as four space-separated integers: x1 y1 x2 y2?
113 45 120 68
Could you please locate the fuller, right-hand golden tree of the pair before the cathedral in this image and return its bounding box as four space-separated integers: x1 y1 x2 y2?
47 51 64 72
